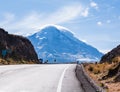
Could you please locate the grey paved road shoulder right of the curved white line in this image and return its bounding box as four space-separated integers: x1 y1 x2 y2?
61 65 83 92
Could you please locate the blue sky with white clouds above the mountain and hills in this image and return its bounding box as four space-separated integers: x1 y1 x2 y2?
0 0 120 52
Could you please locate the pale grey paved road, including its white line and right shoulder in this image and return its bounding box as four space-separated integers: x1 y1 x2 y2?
0 64 83 92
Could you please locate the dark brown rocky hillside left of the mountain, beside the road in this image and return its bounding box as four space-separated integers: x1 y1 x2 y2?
0 28 39 64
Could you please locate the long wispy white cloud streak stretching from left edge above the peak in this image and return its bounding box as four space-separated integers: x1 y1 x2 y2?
0 4 86 35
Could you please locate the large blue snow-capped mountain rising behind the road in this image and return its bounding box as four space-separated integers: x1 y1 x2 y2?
28 25 102 63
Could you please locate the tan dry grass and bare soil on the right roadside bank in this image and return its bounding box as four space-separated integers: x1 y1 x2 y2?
85 61 120 92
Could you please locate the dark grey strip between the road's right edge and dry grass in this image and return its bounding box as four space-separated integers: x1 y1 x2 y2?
76 65 105 92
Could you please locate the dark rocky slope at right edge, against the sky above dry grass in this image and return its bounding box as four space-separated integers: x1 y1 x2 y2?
100 45 120 63
